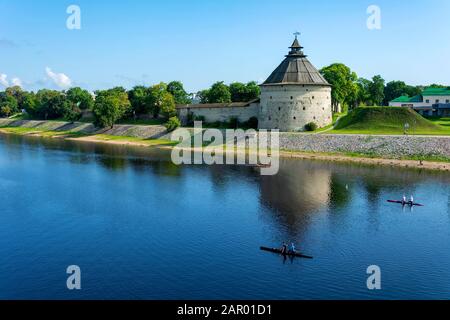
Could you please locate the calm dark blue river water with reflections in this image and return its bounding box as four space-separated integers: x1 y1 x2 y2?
0 136 450 299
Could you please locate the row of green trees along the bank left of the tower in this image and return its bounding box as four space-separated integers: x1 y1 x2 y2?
0 81 260 128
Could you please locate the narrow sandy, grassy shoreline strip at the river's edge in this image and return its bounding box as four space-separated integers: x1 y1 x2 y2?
0 128 450 172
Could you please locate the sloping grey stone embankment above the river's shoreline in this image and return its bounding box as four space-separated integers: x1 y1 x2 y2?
0 119 450 159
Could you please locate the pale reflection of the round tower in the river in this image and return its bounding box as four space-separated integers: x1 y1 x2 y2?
261 160 331 235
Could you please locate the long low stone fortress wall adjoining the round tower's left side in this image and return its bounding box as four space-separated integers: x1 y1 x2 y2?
178 103 259 123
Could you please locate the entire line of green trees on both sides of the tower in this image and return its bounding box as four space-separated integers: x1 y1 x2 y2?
0 69 445 129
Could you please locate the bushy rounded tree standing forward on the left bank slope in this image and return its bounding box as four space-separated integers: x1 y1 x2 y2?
93 87 131 128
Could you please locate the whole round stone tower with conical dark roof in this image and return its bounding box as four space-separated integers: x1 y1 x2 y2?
259 36 333 131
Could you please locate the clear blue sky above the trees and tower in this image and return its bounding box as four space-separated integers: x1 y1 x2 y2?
0 0 450 92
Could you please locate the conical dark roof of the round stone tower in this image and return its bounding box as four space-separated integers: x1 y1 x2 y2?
263 37 330 86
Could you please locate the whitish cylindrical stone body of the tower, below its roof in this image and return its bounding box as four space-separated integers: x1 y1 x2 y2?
259 85 333 131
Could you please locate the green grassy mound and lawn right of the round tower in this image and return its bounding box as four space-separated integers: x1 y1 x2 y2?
328 107 450 135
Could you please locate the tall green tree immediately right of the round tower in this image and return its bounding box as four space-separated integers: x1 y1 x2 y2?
320 63 358 112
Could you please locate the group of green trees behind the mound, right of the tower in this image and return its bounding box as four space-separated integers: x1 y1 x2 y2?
320 63 445 112
